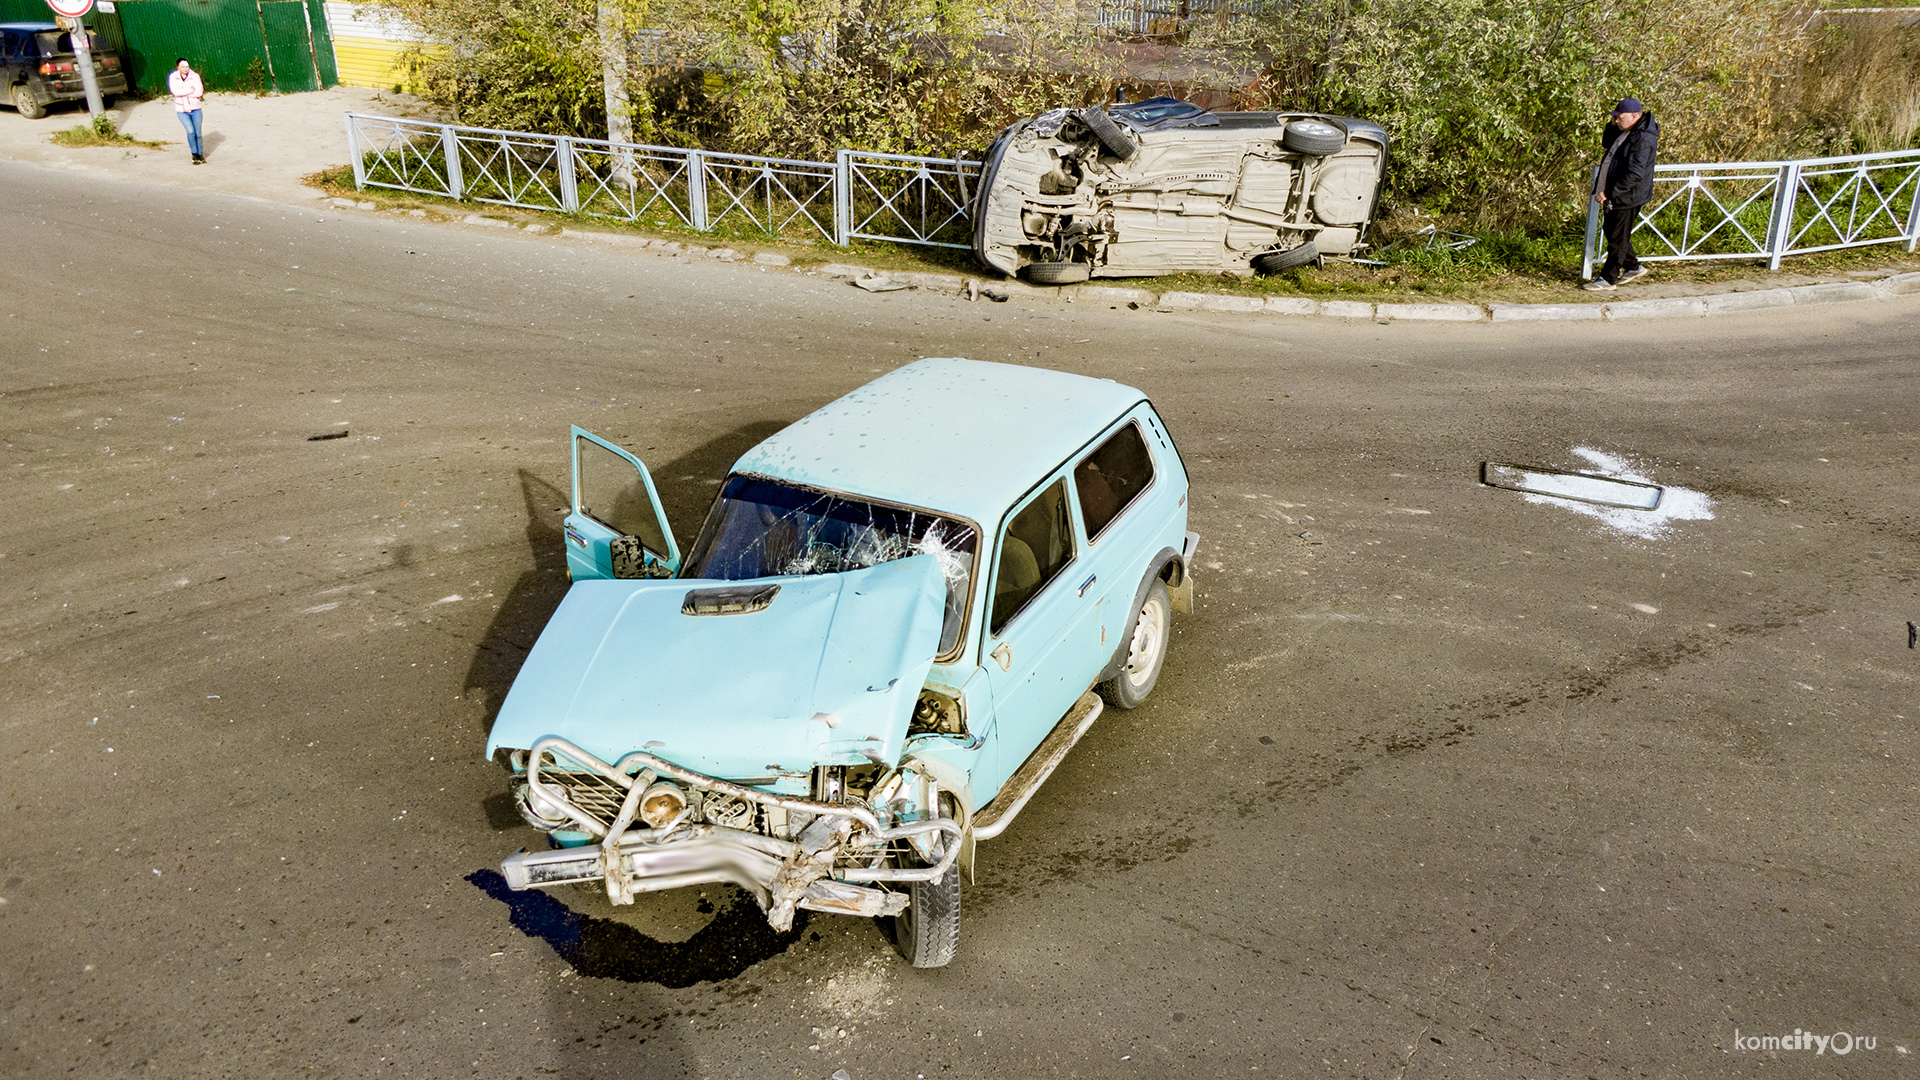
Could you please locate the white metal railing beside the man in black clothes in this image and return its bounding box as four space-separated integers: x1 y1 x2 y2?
1580 150 1920 279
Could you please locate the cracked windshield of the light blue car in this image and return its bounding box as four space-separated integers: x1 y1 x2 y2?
682 477 975 653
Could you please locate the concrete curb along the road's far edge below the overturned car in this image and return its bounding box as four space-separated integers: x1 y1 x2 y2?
476 215 1920 323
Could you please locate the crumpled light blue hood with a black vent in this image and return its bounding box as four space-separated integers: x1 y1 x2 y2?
486 555 947 778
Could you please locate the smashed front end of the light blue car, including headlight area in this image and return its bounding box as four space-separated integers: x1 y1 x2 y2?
501 738 962 930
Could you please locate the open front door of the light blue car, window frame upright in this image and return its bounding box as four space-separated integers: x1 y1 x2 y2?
566 427 680 580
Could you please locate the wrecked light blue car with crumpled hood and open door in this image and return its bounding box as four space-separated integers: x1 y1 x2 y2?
488 359 1198 967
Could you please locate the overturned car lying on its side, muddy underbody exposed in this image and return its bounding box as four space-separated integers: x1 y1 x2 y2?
973 98 1386 284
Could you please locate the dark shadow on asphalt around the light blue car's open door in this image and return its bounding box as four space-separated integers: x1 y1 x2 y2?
465 419 789 734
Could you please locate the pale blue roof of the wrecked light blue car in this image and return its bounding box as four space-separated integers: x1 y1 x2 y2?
733 357 1146 530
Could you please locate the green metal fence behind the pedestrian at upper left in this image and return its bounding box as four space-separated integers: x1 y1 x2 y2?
0 0 340 94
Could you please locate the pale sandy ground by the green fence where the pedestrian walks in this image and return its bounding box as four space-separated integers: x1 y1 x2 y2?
0 86 419 202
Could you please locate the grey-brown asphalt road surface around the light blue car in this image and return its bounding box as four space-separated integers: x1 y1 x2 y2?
0 163 1920 1080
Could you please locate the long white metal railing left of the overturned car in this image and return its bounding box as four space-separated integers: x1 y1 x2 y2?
346 113 981 248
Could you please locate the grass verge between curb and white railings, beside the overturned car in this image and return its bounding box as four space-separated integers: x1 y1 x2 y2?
303 165 1920 304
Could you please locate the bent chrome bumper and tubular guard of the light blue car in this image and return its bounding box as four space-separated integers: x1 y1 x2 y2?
499 738 962 930
